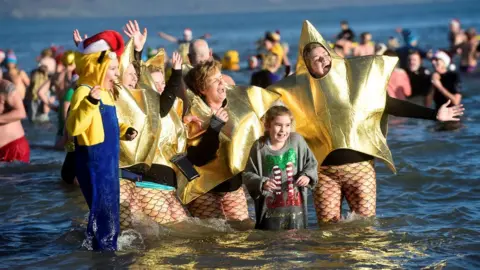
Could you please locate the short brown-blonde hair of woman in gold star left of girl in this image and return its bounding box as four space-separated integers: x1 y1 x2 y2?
185 60 222 96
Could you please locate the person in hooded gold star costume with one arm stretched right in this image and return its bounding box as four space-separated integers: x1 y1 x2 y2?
269 21 463 222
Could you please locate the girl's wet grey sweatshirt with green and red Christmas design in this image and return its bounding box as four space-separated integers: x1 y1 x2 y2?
242 132 318 230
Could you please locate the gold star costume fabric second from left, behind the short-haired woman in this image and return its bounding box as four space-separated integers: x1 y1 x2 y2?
140 45 187 172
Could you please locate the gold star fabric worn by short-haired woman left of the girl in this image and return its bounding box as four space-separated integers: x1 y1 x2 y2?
178 86 279 204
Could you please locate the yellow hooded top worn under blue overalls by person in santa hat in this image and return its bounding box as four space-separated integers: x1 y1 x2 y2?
66 48 129 146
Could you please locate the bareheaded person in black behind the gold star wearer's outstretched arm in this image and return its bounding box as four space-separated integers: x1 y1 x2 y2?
406 51 432 108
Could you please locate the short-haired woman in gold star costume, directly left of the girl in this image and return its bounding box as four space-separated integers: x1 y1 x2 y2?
183 61 278 221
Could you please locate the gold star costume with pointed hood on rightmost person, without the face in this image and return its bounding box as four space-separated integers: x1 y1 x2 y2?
268 21 398 172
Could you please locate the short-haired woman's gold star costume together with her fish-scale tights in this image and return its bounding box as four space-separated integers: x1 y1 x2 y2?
178 86 279 220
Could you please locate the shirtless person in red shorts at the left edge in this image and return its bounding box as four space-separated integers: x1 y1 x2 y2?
0 79 30 163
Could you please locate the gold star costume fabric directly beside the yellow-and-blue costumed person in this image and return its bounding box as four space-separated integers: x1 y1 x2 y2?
115 40 161 169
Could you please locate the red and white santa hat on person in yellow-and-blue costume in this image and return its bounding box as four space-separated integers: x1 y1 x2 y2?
78 30 125 59
